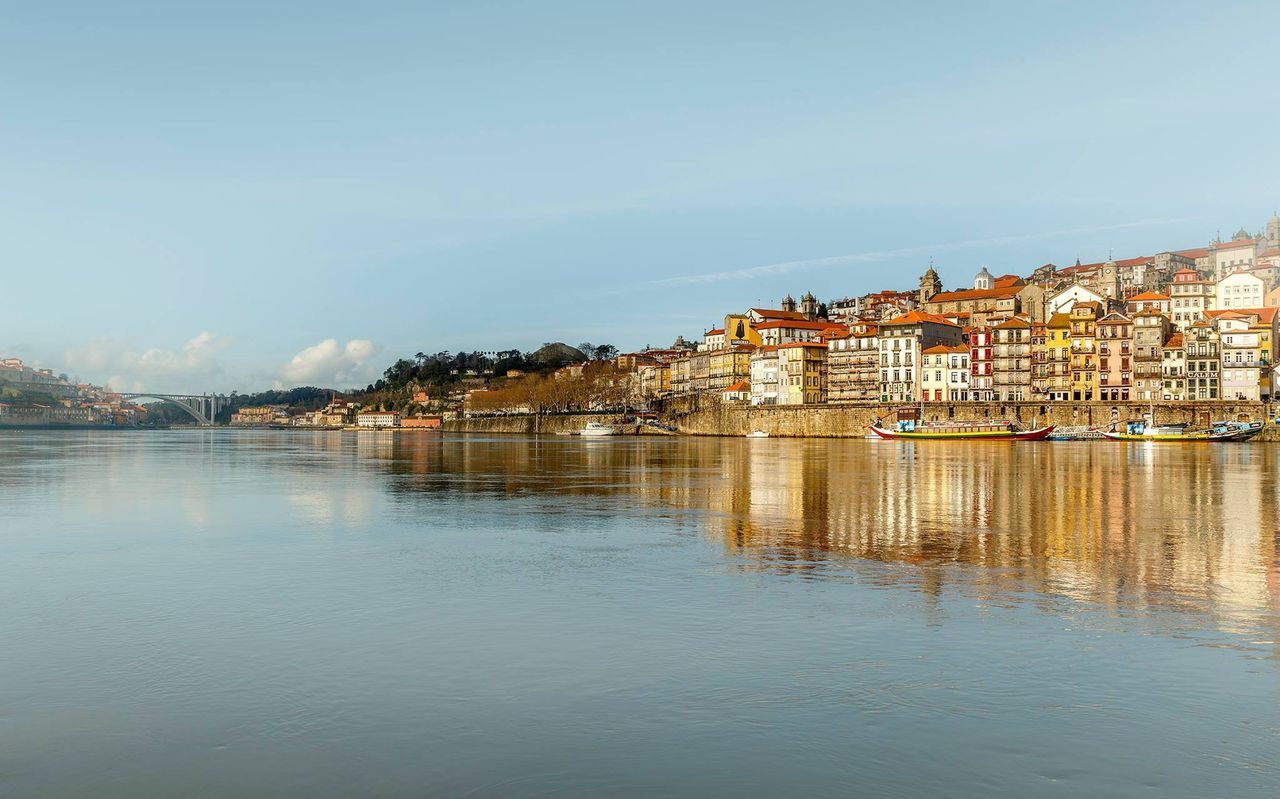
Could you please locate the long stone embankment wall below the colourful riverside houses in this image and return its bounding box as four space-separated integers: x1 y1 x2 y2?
664 397 1280 440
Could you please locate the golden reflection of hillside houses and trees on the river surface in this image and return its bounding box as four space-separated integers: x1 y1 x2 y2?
361 437 1280 645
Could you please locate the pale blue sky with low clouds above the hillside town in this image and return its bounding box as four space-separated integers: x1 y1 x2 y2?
0 0 1280 391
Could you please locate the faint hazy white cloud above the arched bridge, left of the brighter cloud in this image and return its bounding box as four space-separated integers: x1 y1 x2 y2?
64 330 232 392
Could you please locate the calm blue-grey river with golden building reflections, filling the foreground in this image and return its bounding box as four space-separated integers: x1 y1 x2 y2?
0 430 1280 798
